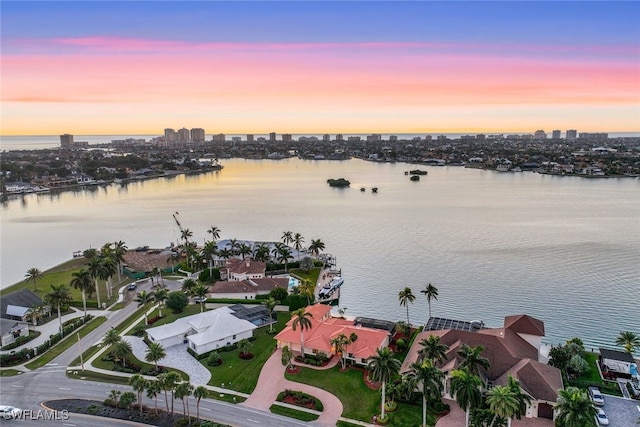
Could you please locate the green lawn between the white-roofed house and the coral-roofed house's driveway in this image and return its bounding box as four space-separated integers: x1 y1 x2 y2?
200 313 291 393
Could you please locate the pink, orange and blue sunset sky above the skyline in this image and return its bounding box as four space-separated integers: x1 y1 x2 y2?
0 1 640 135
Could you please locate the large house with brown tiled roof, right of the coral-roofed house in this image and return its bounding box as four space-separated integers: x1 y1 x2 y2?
400 315 563 419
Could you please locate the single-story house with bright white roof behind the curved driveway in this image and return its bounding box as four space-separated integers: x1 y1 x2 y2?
147 307 257 354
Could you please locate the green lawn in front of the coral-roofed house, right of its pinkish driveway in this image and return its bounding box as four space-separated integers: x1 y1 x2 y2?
285 366 380 422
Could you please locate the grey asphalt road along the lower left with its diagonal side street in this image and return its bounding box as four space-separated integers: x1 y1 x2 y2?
0 280 313 427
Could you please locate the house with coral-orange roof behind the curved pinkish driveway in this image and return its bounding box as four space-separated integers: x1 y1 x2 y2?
275 304 390 366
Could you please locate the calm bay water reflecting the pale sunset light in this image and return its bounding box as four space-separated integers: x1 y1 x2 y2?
0 159 640 347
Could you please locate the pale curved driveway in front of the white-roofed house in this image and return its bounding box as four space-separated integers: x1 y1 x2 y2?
123 335 211 386
